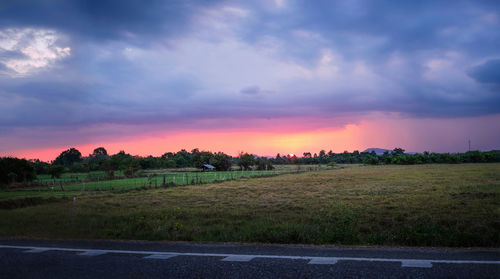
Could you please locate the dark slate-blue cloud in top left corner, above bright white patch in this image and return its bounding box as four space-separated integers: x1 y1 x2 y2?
0 0 224 44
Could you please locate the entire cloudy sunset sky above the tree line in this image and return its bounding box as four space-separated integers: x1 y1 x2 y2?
0 0 500 161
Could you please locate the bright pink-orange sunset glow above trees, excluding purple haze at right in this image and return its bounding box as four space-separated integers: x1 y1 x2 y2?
6 125 368 161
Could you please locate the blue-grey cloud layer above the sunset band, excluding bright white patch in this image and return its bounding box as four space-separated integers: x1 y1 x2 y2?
0 1 500 136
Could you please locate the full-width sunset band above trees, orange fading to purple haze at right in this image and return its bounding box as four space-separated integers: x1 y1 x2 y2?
1 115 500 161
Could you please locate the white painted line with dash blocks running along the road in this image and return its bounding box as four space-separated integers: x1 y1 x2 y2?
0 245 500 267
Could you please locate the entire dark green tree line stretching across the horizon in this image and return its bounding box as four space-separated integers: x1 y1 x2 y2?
0 147 500 185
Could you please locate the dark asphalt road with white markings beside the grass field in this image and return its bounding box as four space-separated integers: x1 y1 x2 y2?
0 239 500 278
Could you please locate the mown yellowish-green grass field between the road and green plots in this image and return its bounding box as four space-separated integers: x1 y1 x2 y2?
0 163 500 247
